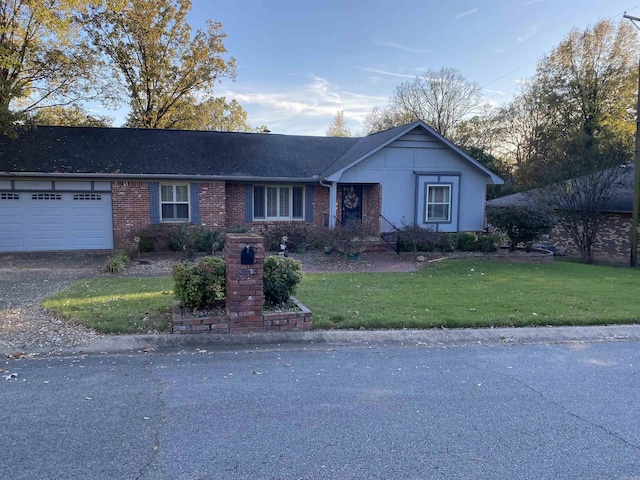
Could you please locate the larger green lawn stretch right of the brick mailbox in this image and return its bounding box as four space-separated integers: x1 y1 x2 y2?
296 259 640 328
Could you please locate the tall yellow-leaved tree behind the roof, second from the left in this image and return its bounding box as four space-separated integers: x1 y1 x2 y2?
83 0 236 128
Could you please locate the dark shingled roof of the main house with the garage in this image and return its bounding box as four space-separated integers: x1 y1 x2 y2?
0 120 502 183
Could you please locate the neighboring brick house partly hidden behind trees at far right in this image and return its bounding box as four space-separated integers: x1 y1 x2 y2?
487 165 635 262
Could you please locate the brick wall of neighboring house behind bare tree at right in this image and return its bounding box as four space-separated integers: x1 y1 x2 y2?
543 213 631 262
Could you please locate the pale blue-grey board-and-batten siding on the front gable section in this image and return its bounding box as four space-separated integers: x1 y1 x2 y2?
339 129 491 231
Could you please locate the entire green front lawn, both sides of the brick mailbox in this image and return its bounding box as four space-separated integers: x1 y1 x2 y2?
43 259 640 333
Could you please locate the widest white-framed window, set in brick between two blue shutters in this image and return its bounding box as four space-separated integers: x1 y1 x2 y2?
253 185 304 220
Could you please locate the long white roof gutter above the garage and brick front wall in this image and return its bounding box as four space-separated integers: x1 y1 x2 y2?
0 172 318 183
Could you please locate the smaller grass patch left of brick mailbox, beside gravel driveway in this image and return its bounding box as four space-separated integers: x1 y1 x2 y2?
42 277 173 333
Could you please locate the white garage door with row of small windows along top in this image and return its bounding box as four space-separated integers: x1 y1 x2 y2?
0 180 113 252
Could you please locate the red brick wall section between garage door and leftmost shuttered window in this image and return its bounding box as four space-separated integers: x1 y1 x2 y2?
111 181 151 248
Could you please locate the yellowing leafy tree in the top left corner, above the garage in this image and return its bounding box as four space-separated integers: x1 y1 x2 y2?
0 0 104 134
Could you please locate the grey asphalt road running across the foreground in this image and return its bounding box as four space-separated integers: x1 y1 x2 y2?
0 342 640 480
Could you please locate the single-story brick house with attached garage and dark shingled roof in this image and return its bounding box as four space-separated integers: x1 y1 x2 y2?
0 121 502 252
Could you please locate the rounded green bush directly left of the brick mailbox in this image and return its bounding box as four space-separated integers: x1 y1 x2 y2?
173 257 226 308
